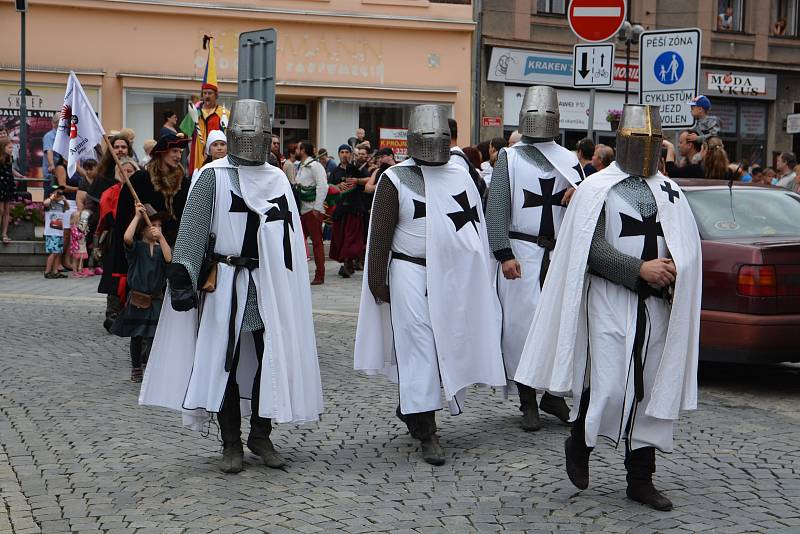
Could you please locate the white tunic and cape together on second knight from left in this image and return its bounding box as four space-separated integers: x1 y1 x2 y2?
354 160 505 414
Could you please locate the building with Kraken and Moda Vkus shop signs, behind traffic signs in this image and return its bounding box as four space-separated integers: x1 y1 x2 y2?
479 0 800 165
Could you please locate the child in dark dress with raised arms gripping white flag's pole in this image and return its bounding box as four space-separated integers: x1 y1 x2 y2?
111 203 172 382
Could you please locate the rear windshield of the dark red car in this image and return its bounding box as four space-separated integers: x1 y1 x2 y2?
686 187 800 239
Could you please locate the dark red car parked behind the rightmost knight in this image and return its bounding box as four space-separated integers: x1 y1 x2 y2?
677 180 800 363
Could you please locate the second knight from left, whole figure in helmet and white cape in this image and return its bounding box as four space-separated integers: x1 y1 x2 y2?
355 105 505 465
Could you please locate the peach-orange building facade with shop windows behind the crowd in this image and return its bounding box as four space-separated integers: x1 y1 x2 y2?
0 0 475 175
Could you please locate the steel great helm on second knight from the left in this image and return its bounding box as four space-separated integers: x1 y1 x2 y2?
407 104 450 163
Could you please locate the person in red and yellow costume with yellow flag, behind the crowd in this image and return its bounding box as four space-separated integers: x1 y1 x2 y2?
179 35 228 176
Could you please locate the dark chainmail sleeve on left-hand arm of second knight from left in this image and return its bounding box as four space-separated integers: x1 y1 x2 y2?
367 179 400 302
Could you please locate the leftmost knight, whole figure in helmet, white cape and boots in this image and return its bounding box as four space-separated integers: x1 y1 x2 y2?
139 100 322 473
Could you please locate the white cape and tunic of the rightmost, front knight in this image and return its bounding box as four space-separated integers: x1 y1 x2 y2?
514 164 702 451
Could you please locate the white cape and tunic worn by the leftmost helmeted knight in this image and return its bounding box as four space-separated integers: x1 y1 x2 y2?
139 158 322 429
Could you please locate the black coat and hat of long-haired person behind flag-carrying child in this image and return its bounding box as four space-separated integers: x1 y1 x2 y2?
100 135 189 314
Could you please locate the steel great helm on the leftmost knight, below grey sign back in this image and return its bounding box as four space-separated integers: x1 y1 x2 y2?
225 99 272 165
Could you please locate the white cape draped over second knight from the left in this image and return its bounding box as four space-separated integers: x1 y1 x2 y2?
354 159 506 408
